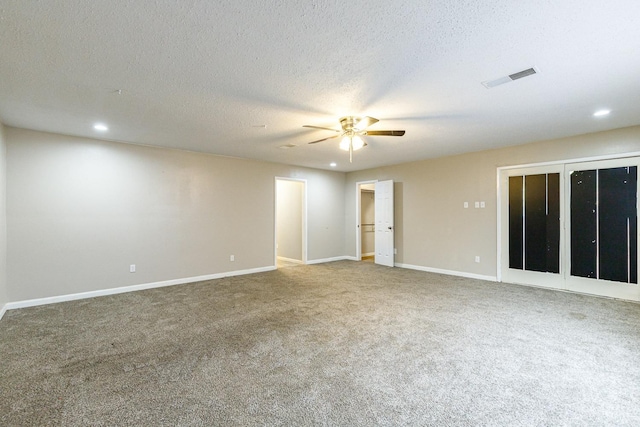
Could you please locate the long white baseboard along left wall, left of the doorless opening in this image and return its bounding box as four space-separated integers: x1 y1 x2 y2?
0 266 276 312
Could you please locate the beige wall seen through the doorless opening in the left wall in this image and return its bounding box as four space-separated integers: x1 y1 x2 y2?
276 179 304 261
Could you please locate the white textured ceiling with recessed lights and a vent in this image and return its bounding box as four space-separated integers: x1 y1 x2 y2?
0 0 640 171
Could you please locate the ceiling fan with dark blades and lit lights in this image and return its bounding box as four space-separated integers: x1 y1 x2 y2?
303 116 405 163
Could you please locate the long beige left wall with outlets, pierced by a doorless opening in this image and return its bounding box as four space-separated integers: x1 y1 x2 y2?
5 127 345 302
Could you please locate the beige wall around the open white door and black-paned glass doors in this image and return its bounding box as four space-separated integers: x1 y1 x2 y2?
345 127 640 277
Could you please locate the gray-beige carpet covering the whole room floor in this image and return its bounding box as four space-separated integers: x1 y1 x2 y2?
0 261 640 426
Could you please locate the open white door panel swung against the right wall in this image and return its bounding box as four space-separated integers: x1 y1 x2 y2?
375 181 394 267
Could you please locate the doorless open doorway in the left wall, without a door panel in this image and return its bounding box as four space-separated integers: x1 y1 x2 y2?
274 178 307 268
